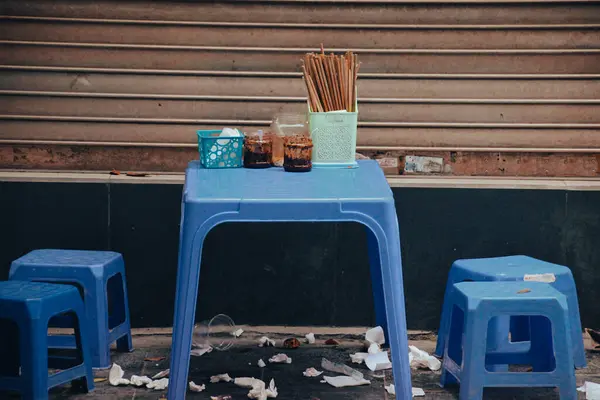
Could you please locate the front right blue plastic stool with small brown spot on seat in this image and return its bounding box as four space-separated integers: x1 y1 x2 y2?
441 282 577 400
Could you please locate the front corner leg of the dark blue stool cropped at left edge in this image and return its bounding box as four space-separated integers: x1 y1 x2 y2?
21 318 48 400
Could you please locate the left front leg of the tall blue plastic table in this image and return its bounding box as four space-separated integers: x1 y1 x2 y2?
167 219 210 400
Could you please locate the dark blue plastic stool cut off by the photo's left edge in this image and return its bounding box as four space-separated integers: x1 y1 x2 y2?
0 281 94 400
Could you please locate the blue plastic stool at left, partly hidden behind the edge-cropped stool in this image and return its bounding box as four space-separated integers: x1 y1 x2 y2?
9 250 133 368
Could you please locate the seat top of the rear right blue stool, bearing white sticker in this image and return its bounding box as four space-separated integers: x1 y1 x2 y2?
453 256 570 279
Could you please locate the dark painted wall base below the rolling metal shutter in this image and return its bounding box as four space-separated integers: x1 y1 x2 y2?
0 182 600 329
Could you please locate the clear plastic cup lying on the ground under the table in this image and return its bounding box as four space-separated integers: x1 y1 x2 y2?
192 314 237 351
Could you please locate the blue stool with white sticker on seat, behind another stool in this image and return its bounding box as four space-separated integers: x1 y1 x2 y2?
435 256 586 369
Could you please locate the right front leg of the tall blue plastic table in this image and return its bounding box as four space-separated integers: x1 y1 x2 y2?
366 211 412 399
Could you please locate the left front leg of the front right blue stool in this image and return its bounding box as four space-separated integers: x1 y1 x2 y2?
460 306 488 400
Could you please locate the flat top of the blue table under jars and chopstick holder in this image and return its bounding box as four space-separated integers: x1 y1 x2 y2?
184 160 393 202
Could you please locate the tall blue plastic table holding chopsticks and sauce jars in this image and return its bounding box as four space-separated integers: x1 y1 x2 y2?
168 160 412 400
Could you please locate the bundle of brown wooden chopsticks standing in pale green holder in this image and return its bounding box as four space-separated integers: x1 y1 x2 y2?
302 46 360 112
